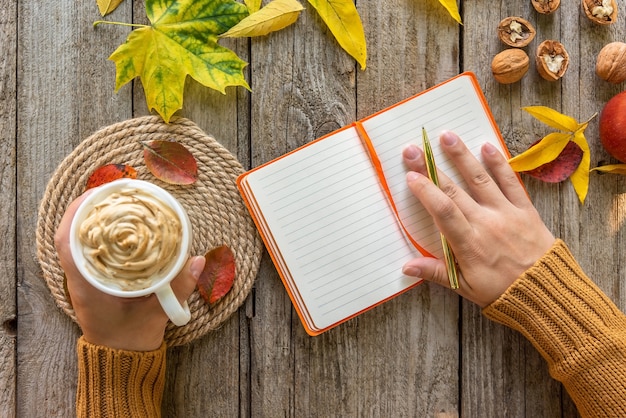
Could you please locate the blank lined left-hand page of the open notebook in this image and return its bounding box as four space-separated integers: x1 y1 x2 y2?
243 128 419 330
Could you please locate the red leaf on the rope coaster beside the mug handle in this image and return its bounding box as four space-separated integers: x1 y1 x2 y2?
198 245 235 304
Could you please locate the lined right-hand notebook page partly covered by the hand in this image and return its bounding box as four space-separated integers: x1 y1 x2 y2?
362 75 503 258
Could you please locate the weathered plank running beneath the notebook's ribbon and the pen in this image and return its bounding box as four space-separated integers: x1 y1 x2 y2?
346 0 459 417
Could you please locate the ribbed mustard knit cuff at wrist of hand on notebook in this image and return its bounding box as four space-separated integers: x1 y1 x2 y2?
483 240 624 363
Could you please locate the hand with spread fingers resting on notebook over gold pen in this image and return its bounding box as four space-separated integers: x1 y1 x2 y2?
403 132 555 307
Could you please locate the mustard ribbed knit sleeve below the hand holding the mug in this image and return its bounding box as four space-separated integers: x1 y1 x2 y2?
76 337 166 418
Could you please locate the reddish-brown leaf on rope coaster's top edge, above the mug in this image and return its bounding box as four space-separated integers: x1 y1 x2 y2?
142 141 198 184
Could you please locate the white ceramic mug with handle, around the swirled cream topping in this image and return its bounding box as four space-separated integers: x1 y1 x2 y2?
70 179 192 326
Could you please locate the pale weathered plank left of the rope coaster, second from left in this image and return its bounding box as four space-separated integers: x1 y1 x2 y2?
16 1 131 416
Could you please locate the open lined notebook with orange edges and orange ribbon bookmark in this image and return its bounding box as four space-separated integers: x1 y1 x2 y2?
237 73 508 335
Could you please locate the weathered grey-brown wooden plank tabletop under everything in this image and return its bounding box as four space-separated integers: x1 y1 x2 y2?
0 0 626 417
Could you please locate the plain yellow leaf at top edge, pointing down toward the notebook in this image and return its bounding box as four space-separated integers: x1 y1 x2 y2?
308 0 367 70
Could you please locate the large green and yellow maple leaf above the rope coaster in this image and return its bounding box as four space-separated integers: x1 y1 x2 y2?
102 0 249 122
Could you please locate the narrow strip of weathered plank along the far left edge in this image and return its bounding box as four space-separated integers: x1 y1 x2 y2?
0 0 17 417
